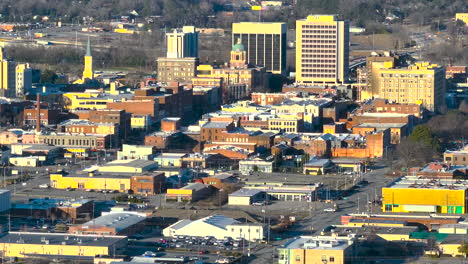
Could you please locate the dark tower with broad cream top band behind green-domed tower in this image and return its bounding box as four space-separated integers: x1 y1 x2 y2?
232 22 287 74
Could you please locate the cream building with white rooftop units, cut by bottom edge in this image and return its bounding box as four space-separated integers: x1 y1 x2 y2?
278 236 354 264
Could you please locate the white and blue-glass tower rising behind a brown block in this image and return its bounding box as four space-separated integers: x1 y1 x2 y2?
166 26 198 59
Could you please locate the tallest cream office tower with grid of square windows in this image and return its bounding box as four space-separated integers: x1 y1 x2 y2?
296 15 349 84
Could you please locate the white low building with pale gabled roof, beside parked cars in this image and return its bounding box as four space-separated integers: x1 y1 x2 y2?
163 214 267 241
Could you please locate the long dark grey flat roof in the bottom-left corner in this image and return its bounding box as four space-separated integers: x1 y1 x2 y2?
0 232 126 247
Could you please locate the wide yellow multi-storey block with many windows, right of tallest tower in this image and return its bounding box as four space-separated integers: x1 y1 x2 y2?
376 62 445 111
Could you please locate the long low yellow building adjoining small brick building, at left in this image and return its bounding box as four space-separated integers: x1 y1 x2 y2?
50 172 131 191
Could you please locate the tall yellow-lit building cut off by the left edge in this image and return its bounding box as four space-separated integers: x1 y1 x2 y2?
0 48 16 97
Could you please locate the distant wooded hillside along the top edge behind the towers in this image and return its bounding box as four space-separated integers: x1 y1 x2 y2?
0 0 468 28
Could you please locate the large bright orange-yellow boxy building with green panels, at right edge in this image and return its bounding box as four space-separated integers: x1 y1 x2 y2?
382 176 468 214
